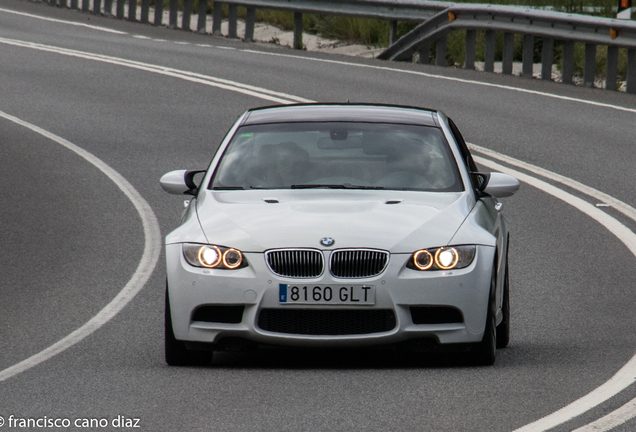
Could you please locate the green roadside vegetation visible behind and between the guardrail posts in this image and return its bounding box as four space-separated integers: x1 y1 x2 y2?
155 0 627 85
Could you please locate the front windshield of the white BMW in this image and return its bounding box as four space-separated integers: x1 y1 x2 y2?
209 123 464 192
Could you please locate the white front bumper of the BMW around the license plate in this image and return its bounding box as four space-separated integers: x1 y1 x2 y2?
166 244 495 347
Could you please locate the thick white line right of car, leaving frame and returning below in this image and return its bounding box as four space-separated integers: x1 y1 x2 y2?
475 155 636 432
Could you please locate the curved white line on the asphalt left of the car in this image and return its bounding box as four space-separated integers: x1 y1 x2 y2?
0 111 162 381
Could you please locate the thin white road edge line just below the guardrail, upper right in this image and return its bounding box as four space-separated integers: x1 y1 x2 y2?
241 49 636 113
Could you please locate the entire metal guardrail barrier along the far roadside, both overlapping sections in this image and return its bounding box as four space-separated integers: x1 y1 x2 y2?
44 0 636 93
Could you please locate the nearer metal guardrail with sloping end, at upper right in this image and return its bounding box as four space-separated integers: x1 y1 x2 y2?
378 5 636 93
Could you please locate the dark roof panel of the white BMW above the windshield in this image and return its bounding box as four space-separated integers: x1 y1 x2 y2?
243 103 439 127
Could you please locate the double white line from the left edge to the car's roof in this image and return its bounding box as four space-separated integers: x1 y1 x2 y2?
0 38 307 104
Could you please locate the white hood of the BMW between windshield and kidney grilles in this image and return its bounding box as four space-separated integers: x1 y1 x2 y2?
197 189 474 253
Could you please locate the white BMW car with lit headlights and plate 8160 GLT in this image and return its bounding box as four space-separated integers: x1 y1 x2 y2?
161 104 519 365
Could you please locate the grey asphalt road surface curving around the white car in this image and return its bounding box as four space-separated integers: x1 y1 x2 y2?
0 0 636 431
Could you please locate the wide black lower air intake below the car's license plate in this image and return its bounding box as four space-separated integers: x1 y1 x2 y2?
258 309 396 336
